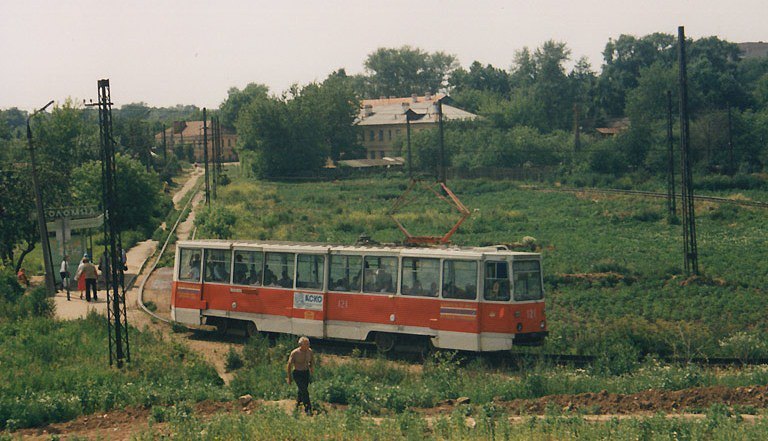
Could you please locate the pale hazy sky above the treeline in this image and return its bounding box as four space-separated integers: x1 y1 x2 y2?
0 0 768 110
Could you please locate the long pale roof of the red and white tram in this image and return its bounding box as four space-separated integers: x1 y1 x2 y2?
177 239 538 258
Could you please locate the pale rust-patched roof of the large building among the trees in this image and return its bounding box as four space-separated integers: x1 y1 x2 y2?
357 94 477 126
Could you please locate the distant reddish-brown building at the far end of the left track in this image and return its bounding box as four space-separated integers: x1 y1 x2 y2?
155 121 237 162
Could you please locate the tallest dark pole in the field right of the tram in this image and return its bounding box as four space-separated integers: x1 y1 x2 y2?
677 26 699 275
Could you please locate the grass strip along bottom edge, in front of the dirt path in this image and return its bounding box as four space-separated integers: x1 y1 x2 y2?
137 406 768 441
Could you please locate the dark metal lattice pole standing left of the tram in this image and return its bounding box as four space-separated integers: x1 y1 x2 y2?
91 79 131 368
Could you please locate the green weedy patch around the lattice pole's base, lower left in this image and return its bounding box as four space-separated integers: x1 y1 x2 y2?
0 272 229 430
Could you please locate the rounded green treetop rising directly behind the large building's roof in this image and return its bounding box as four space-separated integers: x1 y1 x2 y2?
364 46 458 98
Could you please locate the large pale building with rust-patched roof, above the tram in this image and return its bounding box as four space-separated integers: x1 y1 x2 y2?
357 94 477 159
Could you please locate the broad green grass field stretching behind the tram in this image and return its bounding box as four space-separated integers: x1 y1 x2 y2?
198 170 768 360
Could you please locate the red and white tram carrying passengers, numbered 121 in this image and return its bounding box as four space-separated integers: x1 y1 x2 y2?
171 240 547 351
